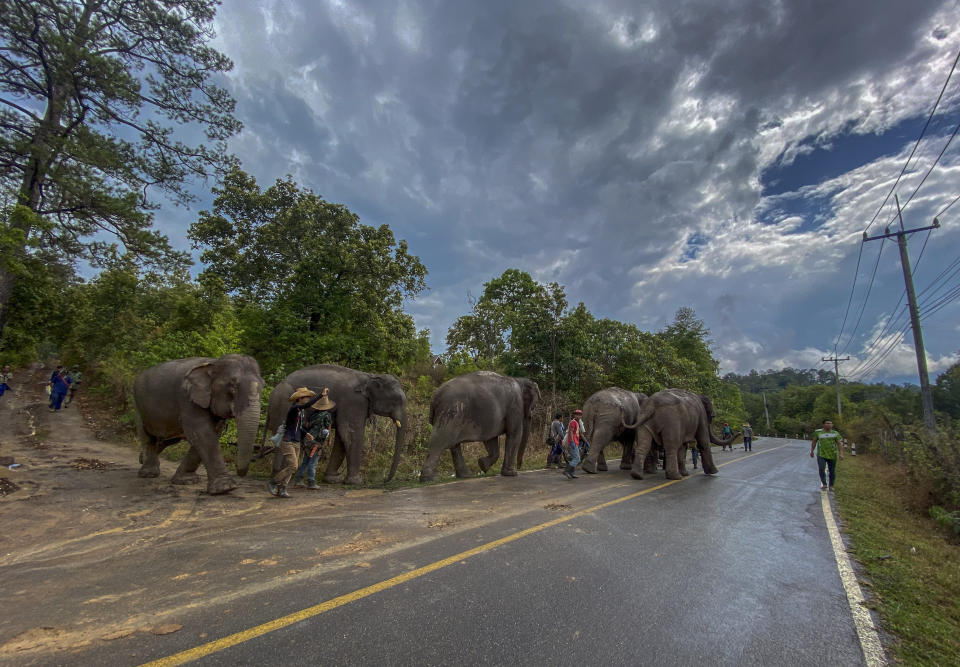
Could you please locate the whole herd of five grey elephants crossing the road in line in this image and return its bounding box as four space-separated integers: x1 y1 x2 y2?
134 354 729 494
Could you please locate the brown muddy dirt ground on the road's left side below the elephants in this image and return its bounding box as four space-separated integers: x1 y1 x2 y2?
0 365 608 664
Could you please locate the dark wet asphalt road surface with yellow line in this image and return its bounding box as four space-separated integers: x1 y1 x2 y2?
30 439 864 665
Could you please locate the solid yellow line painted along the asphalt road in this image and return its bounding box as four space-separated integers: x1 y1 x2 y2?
142 445 787 667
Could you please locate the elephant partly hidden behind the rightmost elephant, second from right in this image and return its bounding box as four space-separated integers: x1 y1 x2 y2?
581 387 656 474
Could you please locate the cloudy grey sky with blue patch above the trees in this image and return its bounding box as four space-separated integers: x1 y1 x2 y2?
157 0 960 383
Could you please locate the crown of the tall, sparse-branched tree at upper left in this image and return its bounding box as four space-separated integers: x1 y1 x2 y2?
0 0 240 334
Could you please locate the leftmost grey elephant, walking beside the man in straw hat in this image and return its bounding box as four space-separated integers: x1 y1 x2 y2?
133 354 263 495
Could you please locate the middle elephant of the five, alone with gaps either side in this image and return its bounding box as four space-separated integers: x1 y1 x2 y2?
420 371 540 482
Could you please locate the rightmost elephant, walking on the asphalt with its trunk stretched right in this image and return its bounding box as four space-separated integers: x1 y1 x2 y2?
623 389 735 479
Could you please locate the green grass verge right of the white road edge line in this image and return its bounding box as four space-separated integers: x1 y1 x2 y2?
836 456 960 666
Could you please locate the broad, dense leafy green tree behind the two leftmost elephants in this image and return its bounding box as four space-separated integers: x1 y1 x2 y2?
188 167 430 373
